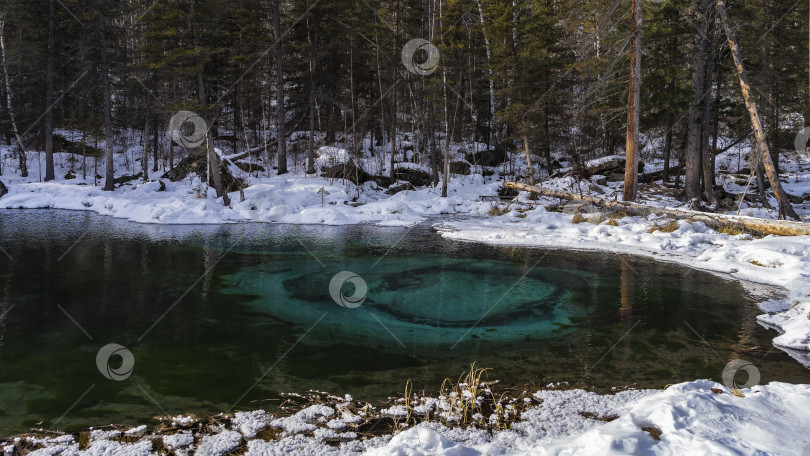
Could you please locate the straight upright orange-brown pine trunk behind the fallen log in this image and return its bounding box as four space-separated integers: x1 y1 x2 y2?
623 0 641 201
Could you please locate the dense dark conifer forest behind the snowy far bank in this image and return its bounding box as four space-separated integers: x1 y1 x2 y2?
0 0 810 218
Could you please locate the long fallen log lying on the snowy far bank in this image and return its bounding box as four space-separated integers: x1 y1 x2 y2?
504 182 810 236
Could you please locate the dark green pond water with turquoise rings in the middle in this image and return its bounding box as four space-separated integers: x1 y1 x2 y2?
0 211 810 436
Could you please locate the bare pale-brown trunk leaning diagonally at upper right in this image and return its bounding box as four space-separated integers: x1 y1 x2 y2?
717 0 801 220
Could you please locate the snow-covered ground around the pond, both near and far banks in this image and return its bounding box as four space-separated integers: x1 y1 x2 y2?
0 134 810 456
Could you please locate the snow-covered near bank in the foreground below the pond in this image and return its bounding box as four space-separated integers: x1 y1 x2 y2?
6 380 810 456
